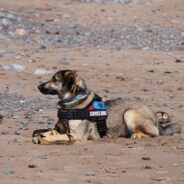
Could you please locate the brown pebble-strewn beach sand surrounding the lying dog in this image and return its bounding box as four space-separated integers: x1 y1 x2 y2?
0 0 184 184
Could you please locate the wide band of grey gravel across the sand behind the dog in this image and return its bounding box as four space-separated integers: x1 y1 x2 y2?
0 10 184 51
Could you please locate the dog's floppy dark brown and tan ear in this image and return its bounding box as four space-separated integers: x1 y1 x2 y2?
62 70 87 93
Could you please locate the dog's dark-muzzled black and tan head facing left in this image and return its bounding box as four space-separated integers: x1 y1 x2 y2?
38 70 87 99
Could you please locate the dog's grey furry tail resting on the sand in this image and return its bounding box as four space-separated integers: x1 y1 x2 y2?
158 123 182 135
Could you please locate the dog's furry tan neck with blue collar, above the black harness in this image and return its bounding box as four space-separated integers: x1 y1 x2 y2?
58 91 95 109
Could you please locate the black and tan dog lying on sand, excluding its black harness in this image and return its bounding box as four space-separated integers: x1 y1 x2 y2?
33 70 181 144
